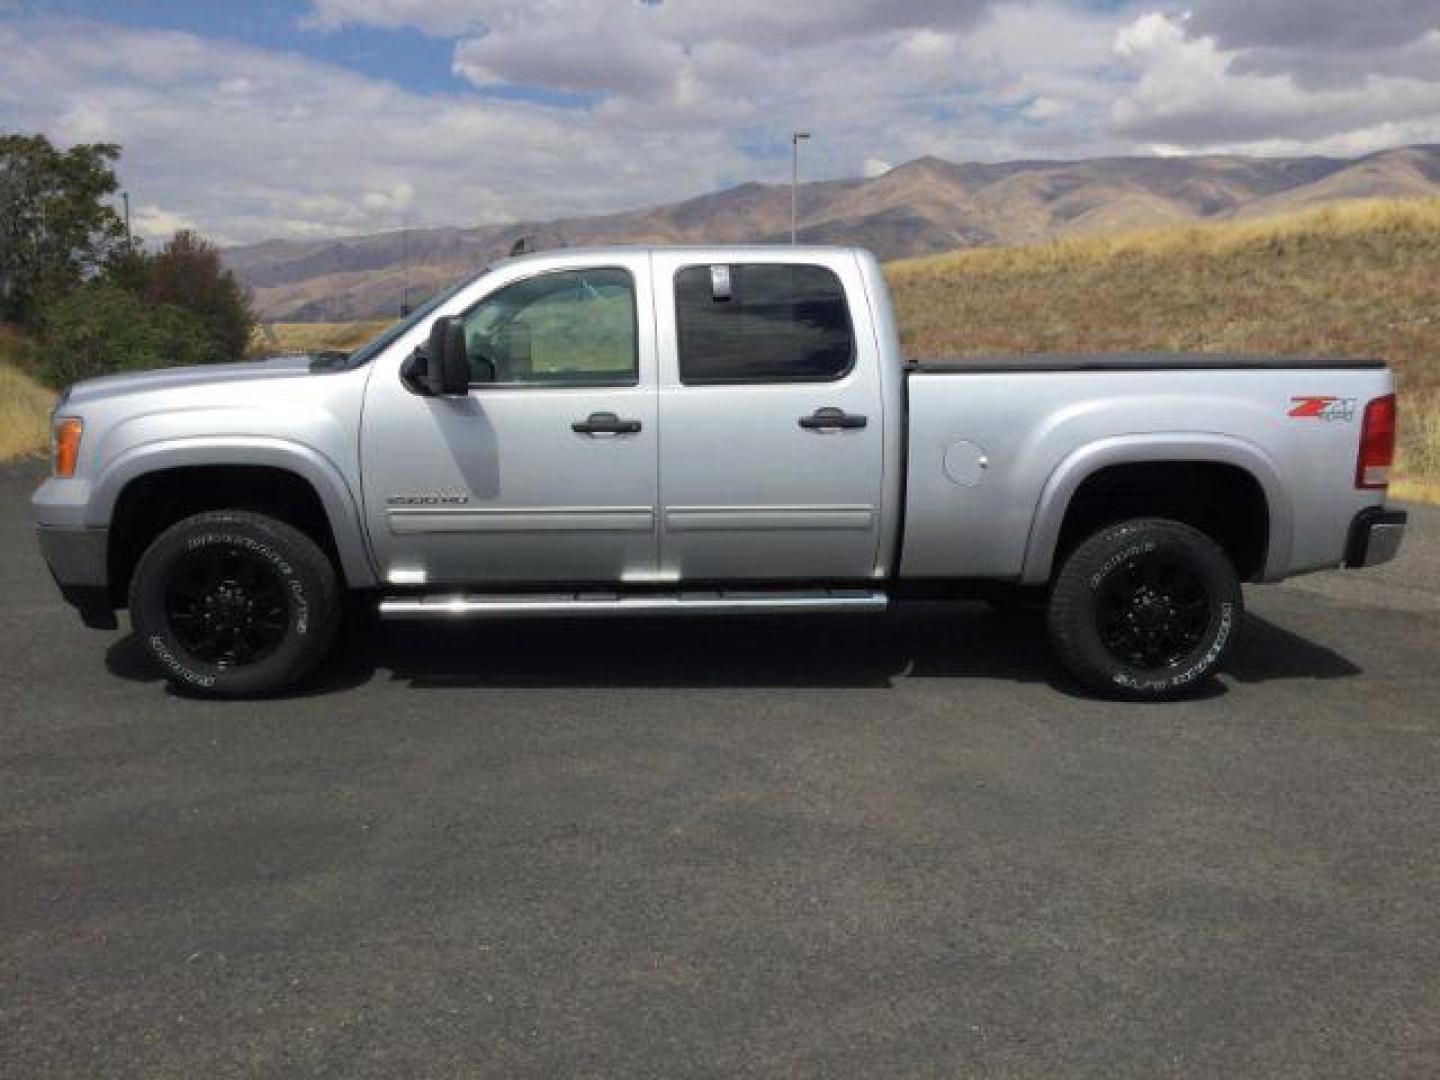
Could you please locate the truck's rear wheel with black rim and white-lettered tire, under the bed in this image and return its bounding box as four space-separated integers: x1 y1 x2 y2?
1048 518 1244 701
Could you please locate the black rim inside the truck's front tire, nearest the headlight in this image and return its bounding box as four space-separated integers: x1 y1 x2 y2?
166 544 289 668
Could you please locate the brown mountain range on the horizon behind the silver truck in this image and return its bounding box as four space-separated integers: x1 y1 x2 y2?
223 145 1440 321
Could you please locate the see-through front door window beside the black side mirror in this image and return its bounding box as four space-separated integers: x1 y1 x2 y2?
465 268 638 386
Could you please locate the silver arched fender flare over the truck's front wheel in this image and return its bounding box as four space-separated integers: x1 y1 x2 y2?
85 435 376 588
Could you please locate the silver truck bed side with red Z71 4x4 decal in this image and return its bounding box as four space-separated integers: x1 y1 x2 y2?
900 360 1394 585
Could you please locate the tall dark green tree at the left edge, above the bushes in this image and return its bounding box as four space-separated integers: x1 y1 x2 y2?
0 135 125 325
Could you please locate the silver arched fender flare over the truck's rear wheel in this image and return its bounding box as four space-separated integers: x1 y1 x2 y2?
1021 432 1295 585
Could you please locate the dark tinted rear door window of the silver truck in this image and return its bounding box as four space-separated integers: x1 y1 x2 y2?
675 264 854 383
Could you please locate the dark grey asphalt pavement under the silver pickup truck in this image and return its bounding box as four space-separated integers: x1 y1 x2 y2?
0 467 1440 1079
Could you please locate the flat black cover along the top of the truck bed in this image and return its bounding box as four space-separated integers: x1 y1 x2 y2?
906 353 1385 374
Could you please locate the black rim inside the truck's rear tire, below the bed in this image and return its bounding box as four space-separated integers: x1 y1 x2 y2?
1097 552 1211 671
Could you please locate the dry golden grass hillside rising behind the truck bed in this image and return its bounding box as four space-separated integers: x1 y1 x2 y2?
887 199 1440 497
